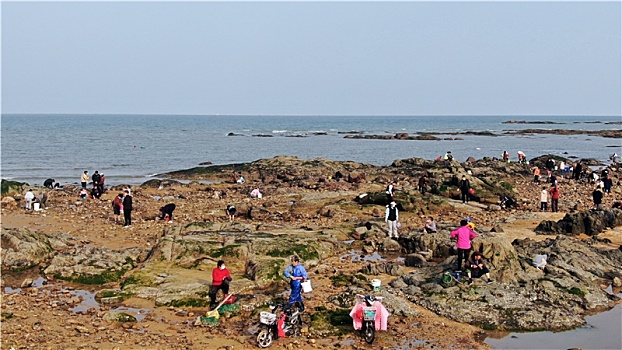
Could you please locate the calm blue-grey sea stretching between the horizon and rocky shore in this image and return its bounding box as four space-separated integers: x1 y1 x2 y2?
0 114 622 185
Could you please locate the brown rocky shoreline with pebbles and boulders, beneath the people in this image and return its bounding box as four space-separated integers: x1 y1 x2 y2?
1 155 622 349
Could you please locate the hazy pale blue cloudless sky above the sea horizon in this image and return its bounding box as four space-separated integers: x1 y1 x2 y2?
1 1 622 116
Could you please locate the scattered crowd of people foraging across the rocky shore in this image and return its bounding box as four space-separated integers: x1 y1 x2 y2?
15 151 613 318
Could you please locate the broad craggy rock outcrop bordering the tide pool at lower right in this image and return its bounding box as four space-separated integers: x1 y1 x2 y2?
391 236 622 331
